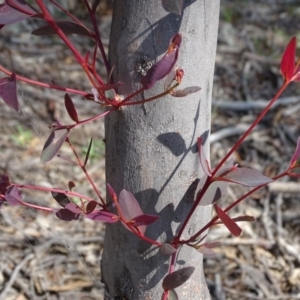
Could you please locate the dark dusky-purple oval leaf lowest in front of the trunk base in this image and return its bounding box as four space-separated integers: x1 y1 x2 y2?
162 267 195 291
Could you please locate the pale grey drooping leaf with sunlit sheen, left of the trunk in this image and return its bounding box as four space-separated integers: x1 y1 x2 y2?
41 128 69 162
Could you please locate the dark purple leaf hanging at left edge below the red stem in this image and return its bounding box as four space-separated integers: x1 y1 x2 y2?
0 72 19 111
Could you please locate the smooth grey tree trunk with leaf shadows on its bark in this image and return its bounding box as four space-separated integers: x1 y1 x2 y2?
101 0 219 300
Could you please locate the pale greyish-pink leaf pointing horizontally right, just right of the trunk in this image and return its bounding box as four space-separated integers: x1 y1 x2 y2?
217 168 273 187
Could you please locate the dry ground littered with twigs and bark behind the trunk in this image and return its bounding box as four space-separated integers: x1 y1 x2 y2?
0 0 300 300
